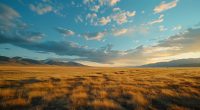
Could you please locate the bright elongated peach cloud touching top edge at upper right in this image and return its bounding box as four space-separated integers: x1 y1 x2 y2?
154 0 179 13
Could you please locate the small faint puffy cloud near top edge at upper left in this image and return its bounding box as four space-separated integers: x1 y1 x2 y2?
29 3 53 15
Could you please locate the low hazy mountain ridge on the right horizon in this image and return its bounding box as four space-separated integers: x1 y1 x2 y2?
140 58 200 67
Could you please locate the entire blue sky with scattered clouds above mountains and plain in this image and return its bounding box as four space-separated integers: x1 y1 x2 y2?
0 0 200 67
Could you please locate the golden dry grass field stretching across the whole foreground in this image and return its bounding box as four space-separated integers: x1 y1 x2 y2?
0 66 200 110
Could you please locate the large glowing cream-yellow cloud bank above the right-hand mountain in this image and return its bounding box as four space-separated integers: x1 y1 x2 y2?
112 28 200 65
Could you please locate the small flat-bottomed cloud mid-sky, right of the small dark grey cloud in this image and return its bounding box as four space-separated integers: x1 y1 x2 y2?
83 32 106 41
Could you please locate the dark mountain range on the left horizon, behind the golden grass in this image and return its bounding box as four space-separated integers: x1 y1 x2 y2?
0 56 86 66
